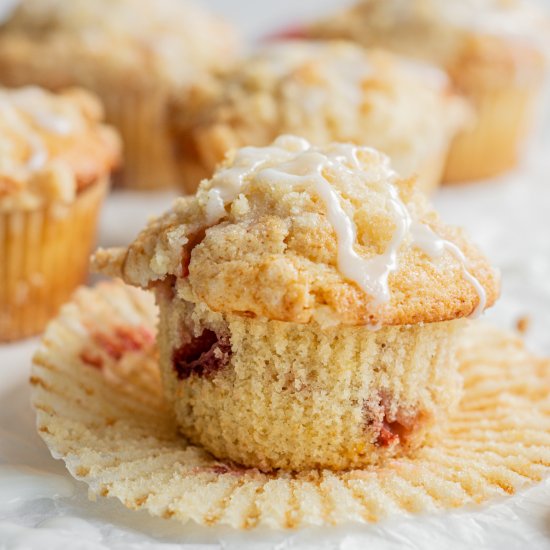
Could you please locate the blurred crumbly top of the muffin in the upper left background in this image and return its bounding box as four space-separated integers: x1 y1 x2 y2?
0 0 237 86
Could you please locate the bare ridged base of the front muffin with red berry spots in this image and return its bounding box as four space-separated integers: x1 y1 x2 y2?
157 292 464 471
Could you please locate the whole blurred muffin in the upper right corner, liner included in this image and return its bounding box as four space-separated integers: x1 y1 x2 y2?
306 0 550 182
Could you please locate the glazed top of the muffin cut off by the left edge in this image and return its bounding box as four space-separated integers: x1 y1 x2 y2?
0 87 120 210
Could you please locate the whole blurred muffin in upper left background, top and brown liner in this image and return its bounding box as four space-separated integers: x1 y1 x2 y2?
0 0 237 189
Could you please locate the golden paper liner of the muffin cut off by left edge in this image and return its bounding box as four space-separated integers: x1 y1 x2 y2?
0 180 108 342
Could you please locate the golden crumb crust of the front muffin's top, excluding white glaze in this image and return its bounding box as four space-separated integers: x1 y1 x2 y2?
96 137 499 325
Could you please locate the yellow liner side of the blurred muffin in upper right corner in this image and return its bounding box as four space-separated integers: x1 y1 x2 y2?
443 86 538 183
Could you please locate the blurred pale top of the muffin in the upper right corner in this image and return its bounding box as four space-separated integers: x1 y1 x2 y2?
306 0 550 78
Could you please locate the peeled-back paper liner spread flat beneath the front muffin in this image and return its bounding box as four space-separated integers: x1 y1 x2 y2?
31 283 550 528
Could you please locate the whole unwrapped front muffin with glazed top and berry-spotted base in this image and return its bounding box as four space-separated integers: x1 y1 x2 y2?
95 136 498 471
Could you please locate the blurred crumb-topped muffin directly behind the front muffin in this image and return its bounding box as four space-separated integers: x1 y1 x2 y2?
171 41 471 193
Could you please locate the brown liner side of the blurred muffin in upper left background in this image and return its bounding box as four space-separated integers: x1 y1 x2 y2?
99 89 179 190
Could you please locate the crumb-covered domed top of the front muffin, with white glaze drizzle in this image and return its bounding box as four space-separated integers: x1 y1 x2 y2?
95 136 499 327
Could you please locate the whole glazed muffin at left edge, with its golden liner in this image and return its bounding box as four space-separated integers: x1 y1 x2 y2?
0 87 120 342
